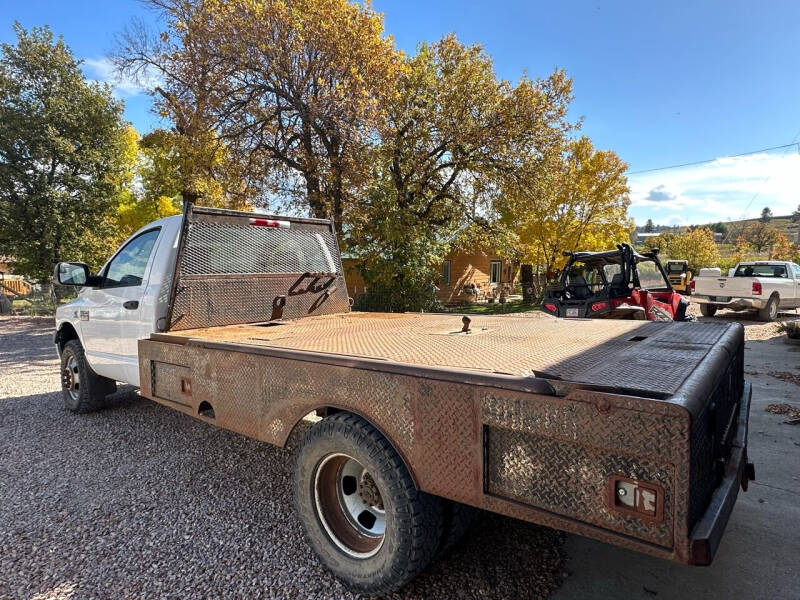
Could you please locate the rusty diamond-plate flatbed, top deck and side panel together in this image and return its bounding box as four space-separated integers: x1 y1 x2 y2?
139 313 741 562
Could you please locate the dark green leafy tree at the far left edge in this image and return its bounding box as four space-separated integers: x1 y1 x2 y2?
0 23 130 281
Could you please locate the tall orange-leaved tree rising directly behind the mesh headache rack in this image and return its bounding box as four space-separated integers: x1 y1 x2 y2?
118 0 400 227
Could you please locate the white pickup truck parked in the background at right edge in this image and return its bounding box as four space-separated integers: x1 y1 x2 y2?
692 261 800 321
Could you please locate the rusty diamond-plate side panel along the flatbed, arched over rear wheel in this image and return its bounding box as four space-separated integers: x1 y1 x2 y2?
139 340 689 560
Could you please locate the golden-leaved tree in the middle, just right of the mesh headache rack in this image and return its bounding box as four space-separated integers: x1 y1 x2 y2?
344 35 571 310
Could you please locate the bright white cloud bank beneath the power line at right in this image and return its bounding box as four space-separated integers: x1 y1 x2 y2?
628 148 800 224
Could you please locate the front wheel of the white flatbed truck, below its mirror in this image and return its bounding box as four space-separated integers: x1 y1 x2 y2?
61 340 117 413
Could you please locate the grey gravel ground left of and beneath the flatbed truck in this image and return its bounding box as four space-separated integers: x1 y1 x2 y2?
0 318 563 600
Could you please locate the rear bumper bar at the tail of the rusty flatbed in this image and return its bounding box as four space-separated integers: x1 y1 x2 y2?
689 381 755 565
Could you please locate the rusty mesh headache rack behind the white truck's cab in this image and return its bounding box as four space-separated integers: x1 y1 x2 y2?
163 203 350 331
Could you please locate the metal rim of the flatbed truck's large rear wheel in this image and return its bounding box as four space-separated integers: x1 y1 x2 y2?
314 454 386 559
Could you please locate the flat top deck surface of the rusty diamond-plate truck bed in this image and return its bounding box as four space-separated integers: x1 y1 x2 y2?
159 313 735 398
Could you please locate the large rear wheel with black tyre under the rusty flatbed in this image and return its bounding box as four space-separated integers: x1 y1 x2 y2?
294 413 444 594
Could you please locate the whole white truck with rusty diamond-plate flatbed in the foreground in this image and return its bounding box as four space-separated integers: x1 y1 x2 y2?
55 204 755 594
